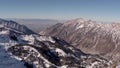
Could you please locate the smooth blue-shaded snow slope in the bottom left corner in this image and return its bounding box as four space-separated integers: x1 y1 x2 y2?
0 45 26 68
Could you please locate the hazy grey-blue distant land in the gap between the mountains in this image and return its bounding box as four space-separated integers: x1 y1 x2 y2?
10 18 63 33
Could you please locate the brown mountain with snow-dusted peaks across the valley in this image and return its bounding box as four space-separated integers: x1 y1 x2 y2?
40 18 120 62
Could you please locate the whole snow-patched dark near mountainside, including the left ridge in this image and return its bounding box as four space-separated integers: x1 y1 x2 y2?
0 19 113 68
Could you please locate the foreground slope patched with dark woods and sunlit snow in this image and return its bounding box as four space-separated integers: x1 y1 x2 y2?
8 35 112 68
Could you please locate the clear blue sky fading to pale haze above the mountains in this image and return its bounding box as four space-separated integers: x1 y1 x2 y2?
0 0 120 21
